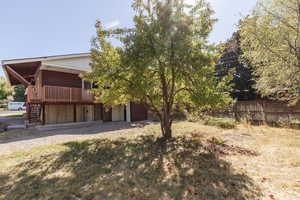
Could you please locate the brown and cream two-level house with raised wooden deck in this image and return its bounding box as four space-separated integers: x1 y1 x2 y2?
2 53 147 124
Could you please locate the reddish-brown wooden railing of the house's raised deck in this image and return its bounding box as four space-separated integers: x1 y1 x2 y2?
27 86 94 103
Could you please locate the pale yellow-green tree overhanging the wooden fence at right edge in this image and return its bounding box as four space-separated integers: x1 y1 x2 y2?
240 0 300 102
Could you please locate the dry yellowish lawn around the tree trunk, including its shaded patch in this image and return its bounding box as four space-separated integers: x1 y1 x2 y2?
0 122 300 200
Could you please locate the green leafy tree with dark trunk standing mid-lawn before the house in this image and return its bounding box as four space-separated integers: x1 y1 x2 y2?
86 0 230 139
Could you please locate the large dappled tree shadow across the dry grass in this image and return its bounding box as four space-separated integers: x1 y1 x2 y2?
0 136 261 200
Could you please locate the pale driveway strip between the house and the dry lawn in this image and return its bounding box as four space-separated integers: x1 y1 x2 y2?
0 122 134 155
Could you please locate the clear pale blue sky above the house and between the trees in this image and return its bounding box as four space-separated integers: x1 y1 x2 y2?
0 0 256 76
